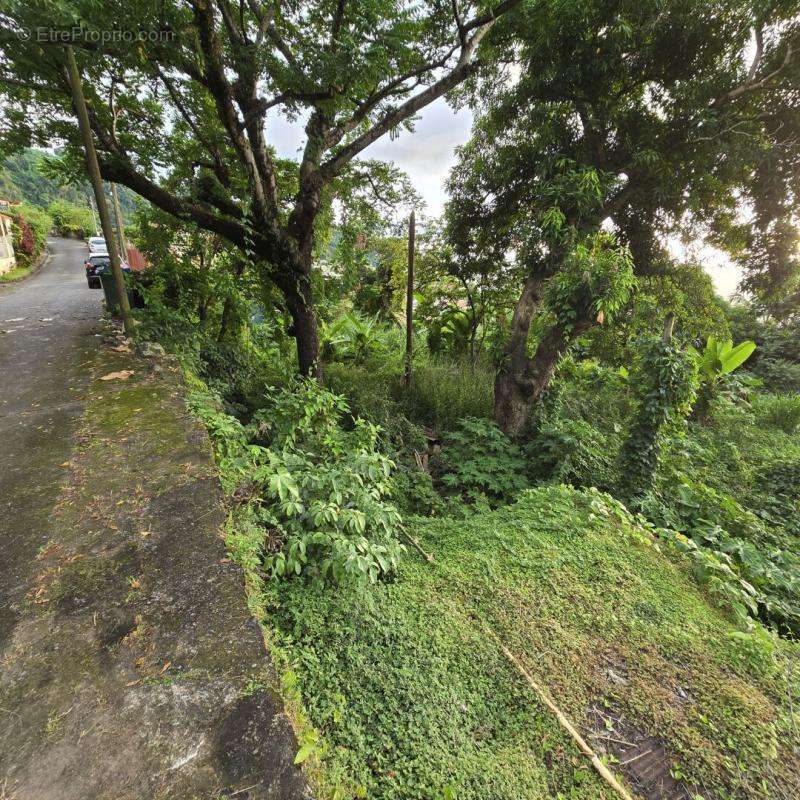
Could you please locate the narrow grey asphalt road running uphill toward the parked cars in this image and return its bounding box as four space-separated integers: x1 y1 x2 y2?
0 239 102 648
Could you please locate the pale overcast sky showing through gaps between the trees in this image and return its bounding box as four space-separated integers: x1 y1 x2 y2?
268 99 739 297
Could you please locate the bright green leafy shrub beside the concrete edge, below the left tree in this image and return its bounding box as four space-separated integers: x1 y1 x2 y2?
195 380 403 586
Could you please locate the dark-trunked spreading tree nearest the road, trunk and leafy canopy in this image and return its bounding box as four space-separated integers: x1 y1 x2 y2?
0 0 519 372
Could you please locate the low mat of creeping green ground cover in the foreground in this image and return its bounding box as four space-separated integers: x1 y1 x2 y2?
251 487 800 800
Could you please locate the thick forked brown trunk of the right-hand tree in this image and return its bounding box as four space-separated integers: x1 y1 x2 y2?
494 275 593 438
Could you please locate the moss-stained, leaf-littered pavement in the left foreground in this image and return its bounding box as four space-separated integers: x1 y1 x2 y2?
0 239 307 800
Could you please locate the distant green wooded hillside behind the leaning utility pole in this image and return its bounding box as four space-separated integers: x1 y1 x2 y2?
0 148 136 219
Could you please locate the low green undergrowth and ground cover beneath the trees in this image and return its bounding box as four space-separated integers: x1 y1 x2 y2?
119 200 800 798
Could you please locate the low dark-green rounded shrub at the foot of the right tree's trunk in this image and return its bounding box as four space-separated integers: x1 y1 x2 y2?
439 418 529 504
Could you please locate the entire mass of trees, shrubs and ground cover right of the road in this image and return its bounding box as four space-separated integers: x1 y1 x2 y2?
0 0 800 800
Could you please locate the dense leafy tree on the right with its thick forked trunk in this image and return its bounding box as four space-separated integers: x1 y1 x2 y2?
448 0 800 431
